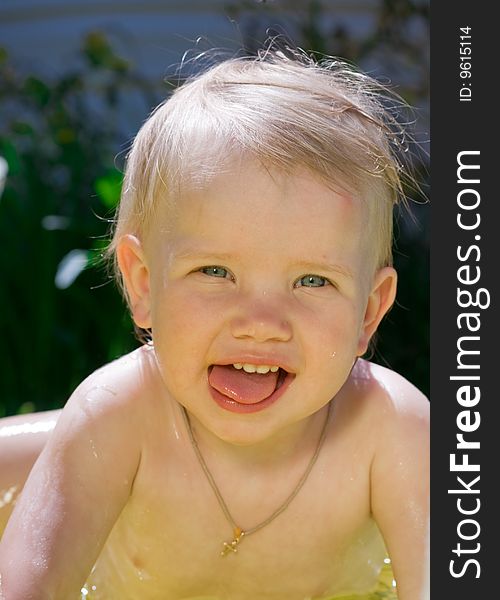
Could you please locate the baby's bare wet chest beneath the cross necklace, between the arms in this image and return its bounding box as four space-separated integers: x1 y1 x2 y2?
85 436 384 600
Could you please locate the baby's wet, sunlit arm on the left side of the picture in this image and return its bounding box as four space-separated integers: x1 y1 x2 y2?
0 376 140 600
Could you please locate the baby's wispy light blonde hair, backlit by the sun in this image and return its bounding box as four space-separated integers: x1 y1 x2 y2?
109 50 410 282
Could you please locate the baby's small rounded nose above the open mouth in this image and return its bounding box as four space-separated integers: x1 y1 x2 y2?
231 298 292 342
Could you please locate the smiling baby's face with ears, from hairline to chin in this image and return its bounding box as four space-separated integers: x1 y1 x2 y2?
120 163 395 444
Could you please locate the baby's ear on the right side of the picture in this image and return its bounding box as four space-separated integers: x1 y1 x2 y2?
357 267 398 356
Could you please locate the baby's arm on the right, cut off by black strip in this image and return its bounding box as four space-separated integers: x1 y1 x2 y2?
371 374 429 600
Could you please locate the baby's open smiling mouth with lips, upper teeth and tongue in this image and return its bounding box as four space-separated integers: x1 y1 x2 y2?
208 363 295 412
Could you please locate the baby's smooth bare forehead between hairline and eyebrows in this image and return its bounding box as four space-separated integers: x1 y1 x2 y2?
153 159 374 266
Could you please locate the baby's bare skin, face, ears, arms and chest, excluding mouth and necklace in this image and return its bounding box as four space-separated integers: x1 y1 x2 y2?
0 165 428 600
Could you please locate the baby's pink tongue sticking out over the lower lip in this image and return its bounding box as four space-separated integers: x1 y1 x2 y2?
208 365 279 404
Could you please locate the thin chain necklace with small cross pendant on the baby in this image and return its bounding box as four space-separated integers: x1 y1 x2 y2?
181 403 331 556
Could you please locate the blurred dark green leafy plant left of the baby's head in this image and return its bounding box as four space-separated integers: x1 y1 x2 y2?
0 33 160 416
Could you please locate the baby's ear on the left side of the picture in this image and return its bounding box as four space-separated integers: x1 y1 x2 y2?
116 235 151 329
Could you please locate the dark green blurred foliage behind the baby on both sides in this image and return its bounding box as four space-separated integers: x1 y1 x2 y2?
0 0 429 417
